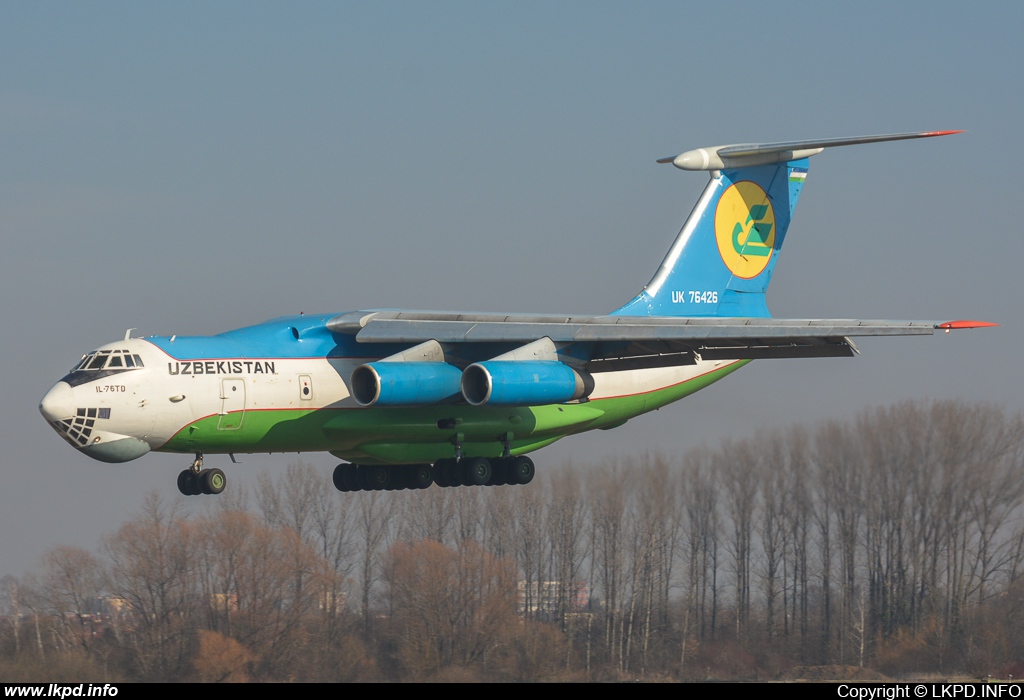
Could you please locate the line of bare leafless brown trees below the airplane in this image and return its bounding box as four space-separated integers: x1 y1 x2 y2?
0 402 1024 681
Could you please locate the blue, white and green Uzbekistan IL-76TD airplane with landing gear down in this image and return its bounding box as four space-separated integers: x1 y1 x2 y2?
39 131 995 495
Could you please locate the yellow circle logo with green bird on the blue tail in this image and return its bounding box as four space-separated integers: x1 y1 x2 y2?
715 180 775 279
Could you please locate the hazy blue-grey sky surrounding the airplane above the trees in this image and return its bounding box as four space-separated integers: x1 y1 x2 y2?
0 0 1024 575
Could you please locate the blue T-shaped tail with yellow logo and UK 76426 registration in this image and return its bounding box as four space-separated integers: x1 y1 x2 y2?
612 131 959 317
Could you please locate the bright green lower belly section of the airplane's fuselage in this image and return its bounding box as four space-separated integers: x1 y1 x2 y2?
159 360 749 464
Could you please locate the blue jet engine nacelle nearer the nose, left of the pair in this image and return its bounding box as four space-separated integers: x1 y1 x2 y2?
351 362 462 406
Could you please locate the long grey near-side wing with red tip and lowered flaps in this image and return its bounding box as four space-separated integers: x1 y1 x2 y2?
328 311 994 371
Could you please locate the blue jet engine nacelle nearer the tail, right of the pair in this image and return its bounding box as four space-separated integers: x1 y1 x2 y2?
462 360 594 406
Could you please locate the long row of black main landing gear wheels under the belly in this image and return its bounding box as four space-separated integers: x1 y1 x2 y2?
334 456 537 492
